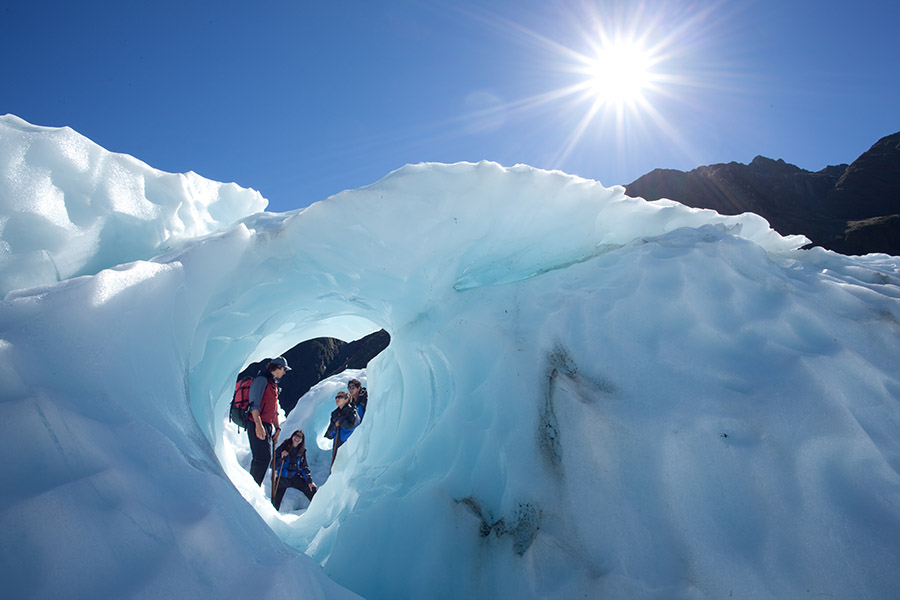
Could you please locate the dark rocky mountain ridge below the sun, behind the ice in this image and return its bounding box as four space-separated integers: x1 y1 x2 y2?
625 133 900 255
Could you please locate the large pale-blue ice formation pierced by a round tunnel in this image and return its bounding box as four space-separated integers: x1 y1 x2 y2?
0 118 900 599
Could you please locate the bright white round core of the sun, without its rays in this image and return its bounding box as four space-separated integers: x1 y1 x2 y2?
585 41 653 107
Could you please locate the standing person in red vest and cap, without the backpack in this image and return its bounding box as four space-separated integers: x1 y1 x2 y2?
247 356 291 485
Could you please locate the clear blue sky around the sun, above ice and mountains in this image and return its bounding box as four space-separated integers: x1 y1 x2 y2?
0 0 900 211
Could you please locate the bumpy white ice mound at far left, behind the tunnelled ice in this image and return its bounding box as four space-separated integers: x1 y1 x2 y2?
0 115 267 296
